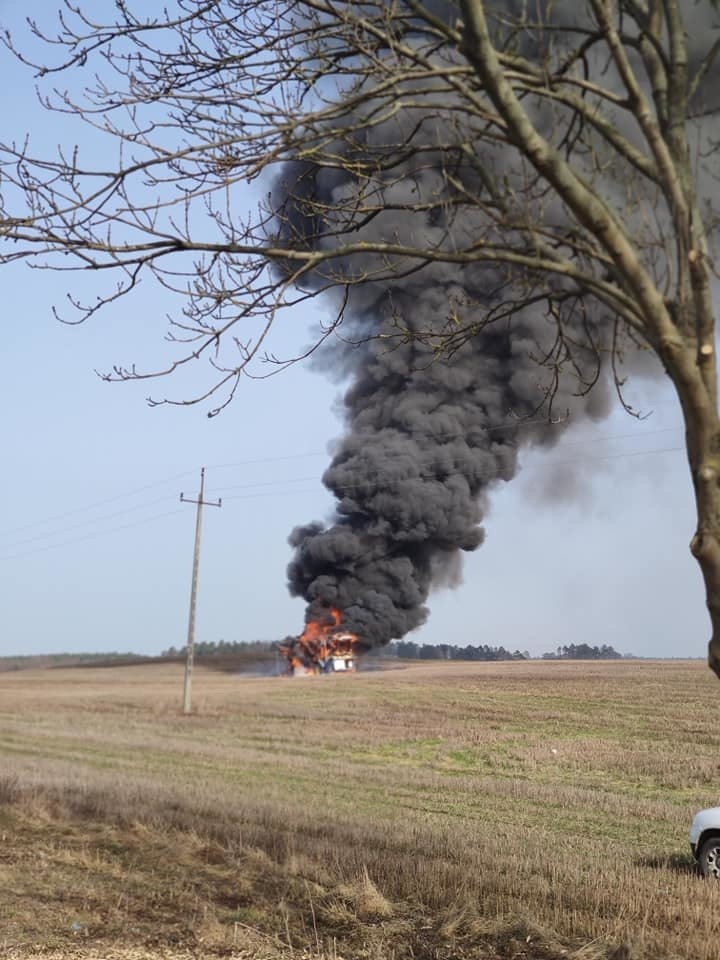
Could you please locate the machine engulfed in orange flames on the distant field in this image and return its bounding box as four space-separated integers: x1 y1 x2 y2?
279 608 361 677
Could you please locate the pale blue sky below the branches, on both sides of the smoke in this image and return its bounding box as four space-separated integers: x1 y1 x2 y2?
0 4 709 656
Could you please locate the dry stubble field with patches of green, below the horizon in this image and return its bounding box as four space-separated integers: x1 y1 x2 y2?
0 662 720 960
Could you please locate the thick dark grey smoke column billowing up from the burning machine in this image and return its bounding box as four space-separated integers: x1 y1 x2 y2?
276 4 720 646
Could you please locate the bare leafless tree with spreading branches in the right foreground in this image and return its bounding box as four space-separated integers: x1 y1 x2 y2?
0 0 720 675
